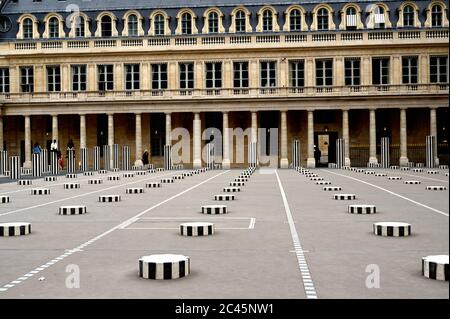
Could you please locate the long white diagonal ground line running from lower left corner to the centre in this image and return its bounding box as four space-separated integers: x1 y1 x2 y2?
0 170 229 292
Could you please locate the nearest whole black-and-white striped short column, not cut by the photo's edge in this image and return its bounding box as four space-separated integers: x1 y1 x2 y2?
139 254 191 280
